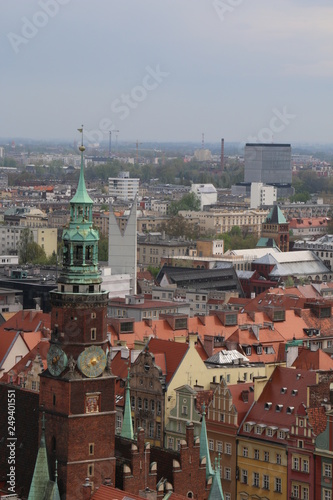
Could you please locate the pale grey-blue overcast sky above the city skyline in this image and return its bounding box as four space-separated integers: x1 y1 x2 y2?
0 0 333 142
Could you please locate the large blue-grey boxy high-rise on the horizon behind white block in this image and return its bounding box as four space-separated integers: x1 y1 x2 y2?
244 143 292 184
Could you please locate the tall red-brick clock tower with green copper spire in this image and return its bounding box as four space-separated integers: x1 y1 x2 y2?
40 129 115 500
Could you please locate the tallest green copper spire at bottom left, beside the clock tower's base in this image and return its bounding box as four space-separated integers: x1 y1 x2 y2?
28 412 50 500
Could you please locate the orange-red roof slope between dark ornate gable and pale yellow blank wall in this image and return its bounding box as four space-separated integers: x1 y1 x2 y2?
148 338 189 384
